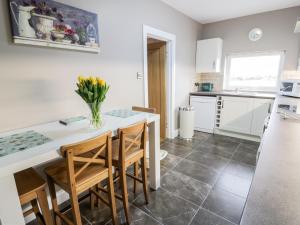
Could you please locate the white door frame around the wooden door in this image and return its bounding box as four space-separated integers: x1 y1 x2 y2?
143 25 177 138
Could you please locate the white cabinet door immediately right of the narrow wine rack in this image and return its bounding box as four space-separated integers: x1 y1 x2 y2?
219 97 253 134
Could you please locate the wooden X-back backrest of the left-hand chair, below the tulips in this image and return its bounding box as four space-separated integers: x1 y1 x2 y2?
60 131 112 185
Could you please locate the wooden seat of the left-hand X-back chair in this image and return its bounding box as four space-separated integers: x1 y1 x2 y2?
45 160 108 193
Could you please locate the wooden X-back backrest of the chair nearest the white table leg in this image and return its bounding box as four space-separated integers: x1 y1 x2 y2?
118 121 147 162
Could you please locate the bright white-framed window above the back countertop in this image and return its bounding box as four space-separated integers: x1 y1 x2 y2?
224 52 284 91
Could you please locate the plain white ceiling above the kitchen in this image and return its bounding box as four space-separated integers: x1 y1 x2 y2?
162 0 300 24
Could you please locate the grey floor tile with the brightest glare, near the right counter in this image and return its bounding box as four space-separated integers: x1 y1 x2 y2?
215 173 252 198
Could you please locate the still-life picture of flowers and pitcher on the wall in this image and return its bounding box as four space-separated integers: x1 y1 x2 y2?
9 0 100 53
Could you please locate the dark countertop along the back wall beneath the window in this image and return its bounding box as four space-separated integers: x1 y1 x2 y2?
190 91 276 99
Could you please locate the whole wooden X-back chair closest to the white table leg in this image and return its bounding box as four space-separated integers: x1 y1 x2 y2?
102 121 148 224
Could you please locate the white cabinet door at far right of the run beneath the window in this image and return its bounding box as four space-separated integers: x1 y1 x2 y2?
251 99 273 136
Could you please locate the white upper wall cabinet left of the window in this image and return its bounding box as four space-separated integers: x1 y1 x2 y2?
196 38 223 73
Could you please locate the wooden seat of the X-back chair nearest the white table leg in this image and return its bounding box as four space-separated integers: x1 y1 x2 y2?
100 139 144 166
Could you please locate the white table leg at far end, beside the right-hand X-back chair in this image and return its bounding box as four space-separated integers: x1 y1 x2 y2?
149 120 160 190
